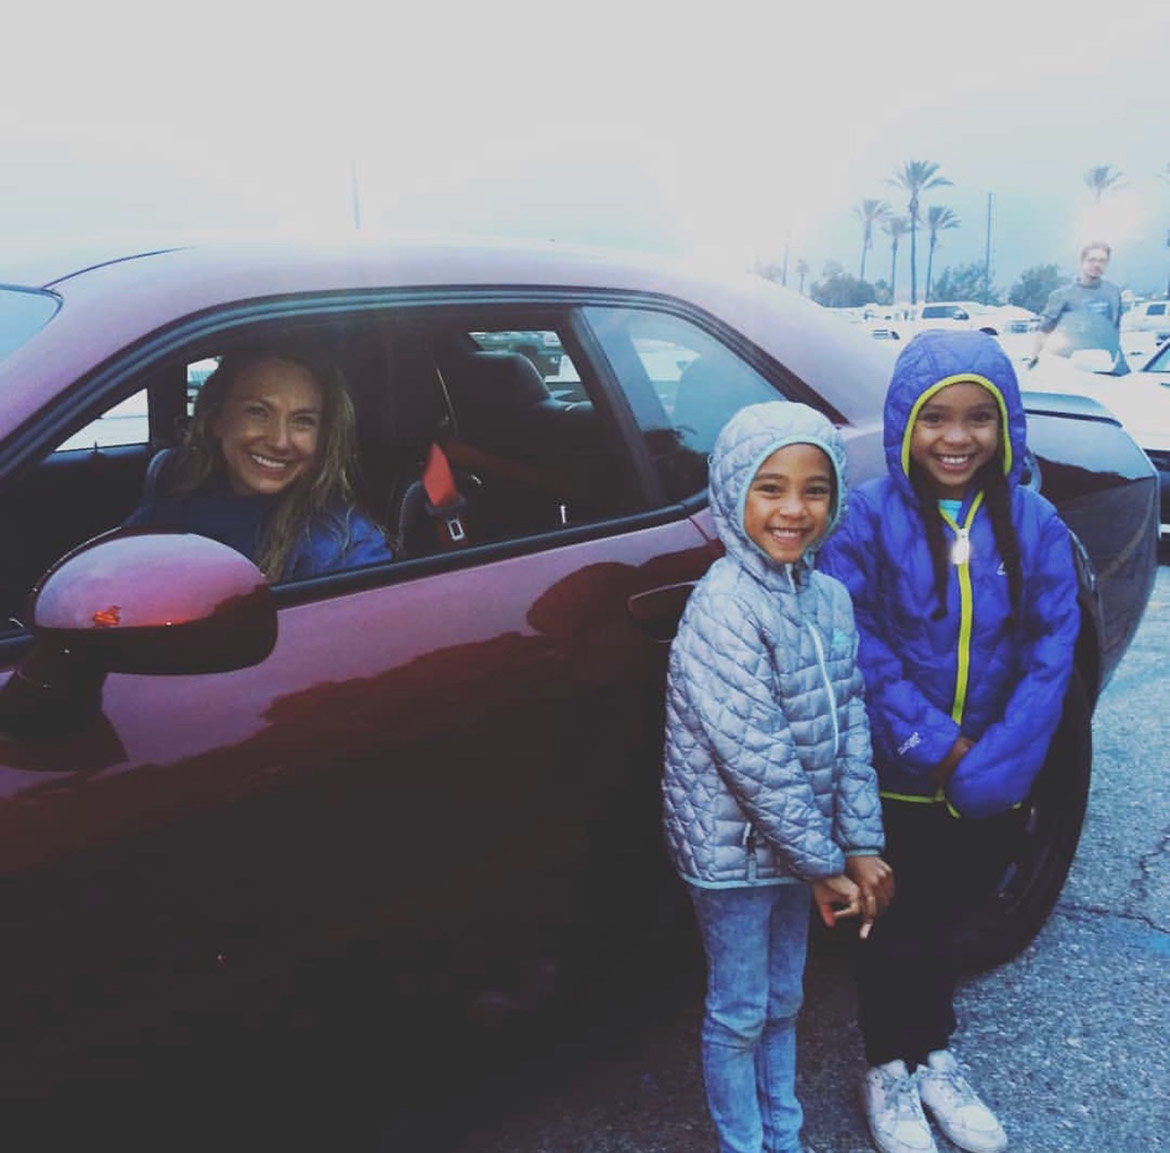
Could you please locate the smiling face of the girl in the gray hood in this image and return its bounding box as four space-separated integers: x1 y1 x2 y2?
743 444 833 564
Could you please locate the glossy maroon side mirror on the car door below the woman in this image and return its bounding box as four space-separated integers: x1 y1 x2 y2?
0 530 276 734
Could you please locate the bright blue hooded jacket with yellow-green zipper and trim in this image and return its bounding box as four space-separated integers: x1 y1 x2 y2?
818 330 1080 817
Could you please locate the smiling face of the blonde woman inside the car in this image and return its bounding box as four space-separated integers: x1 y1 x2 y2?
211 357 322 495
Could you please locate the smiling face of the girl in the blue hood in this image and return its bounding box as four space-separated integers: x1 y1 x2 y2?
910 380 999 500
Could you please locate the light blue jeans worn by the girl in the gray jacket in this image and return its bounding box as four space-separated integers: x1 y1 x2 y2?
690 884 810 1153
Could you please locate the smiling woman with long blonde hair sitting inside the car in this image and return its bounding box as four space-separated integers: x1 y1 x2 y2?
125 339 392 582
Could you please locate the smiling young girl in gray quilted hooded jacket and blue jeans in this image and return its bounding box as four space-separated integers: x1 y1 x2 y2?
662 402 894 1153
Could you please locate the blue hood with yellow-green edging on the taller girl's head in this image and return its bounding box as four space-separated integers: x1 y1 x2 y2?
882 329 1027 500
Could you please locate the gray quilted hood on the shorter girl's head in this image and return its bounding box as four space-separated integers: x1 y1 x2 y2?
709 400 847 576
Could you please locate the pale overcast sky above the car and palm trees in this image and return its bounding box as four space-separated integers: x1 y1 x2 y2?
9 0 1170 295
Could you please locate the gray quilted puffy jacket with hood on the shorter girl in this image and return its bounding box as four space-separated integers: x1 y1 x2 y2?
662 402 883 888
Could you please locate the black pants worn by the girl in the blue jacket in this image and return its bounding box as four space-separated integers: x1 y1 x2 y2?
856 801 1023 1070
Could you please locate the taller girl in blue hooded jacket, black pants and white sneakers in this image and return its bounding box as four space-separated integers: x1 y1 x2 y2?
820 330 1079 1153
